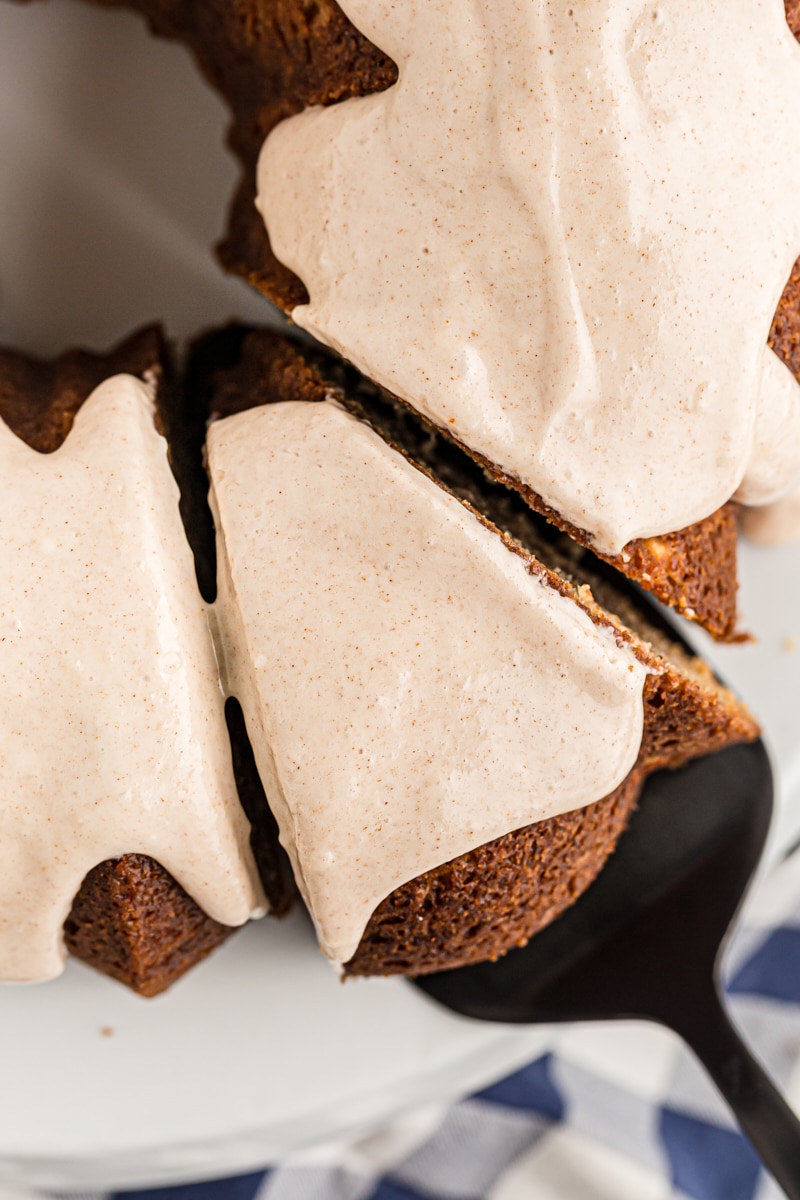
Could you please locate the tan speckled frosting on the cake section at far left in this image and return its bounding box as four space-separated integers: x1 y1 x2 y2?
0 376 264 982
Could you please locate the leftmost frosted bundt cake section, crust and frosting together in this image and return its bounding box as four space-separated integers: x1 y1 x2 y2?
0 329 286 996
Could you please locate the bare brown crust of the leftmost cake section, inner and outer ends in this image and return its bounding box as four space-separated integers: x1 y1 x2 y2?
0 328 293 996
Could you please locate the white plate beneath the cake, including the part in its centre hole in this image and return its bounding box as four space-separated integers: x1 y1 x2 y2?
0 0 800 1189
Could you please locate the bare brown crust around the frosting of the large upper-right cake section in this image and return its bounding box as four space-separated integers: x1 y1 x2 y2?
61 0 800 641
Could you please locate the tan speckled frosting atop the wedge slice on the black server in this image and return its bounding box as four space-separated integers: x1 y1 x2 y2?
207 402 646 962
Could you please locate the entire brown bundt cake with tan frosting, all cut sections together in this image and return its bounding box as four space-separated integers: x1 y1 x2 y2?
0 0 782 995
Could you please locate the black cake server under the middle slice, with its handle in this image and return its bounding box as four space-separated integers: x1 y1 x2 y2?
415 742 800 1200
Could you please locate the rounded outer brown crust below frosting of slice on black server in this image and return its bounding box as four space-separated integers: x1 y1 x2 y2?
344 619 758 976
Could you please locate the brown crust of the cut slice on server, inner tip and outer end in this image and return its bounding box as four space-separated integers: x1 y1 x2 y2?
194 326 758 974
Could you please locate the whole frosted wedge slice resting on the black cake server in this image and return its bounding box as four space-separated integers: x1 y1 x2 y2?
194 329 757 974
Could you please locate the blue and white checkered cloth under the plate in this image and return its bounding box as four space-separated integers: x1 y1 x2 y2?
9 853 800 1200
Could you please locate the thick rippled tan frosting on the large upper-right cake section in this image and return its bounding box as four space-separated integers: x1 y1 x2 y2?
258 0 800 553
